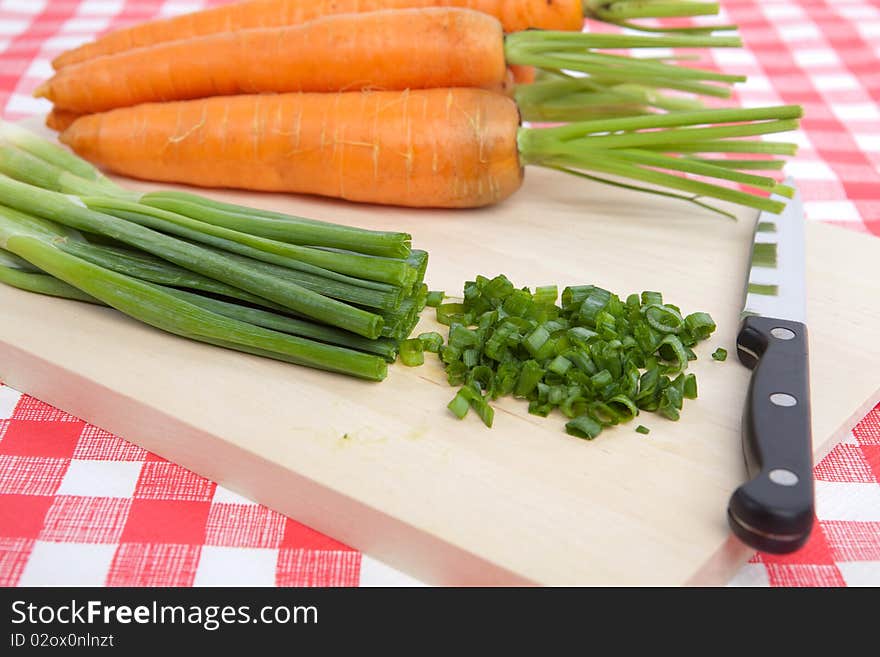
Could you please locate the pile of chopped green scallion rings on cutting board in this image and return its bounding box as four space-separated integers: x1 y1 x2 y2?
400 276 715 439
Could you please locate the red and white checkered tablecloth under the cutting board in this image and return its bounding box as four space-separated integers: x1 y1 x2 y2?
0 0 880 586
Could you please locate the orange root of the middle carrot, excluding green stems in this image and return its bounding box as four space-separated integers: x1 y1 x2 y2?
37 7 506 113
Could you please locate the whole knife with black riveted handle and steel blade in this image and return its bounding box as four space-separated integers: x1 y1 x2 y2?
727 179 815 554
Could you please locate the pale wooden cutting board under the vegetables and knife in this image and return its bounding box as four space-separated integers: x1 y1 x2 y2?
0 156 880 585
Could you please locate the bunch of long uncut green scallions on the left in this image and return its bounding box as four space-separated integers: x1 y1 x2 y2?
0 122 428 381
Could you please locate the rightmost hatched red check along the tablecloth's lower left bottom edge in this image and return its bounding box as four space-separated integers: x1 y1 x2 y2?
275 549 361 587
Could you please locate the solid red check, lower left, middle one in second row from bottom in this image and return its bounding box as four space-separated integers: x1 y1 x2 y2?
121 499 211 545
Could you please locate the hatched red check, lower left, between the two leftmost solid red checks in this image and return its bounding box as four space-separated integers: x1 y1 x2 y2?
39 495 131 543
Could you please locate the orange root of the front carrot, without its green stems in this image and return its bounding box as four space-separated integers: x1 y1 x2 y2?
61 89 523 207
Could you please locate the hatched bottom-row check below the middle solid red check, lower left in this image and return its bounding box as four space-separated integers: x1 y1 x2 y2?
106 543 201 586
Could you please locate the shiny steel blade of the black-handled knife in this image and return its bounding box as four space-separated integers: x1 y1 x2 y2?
742 179 807 323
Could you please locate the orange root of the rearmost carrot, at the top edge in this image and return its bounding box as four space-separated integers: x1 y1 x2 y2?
52 0 584 69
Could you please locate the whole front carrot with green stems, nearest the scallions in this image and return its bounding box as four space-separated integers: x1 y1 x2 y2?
60 88 801 214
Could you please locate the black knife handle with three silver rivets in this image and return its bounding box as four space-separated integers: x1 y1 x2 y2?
727 316 814 554
